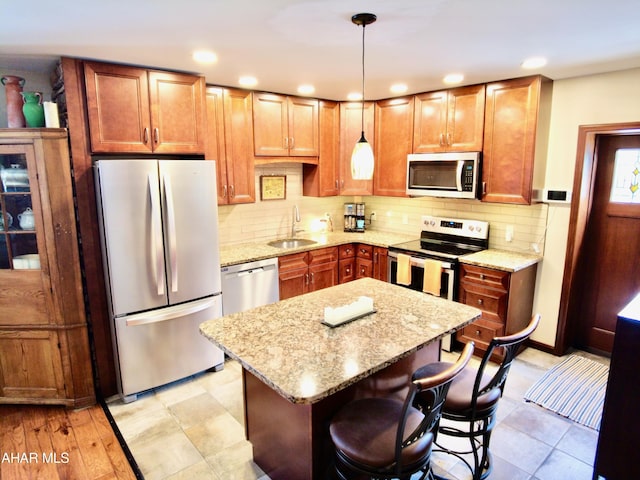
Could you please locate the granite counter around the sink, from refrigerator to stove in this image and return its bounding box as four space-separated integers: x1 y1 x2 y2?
220 231 412 267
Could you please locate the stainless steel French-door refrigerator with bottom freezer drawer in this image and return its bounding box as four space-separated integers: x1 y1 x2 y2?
94 159 224 402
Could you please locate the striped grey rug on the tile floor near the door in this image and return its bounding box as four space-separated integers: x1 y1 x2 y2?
524 355 609 430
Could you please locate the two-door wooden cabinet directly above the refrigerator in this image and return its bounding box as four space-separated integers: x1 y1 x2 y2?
84 62 205 154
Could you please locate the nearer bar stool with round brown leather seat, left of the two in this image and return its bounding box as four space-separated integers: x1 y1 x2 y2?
329 342 474 480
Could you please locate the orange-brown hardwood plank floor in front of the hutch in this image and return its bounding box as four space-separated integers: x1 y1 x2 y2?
0 405 141 480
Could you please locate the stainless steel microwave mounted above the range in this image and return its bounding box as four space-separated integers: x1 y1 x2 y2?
407 152 481 198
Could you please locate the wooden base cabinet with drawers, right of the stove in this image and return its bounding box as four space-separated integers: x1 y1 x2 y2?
456 263 537 357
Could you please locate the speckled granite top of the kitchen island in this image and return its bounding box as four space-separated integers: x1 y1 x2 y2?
200 278 480 404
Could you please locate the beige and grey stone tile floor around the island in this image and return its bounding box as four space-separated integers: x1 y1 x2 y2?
108 349 608 480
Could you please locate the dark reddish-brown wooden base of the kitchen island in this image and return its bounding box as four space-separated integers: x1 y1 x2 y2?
242 341 440 480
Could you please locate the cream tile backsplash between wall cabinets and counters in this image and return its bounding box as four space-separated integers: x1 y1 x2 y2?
219 163 548 253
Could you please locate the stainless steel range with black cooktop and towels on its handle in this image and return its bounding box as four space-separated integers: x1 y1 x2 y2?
388 216 489 300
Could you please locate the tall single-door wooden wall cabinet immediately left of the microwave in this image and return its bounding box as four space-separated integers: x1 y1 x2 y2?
373 96 414 197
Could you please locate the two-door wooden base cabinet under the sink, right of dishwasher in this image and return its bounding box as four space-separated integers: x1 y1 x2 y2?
278 247 338 300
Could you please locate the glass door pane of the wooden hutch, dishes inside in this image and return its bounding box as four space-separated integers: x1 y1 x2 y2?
0 145 40 270
